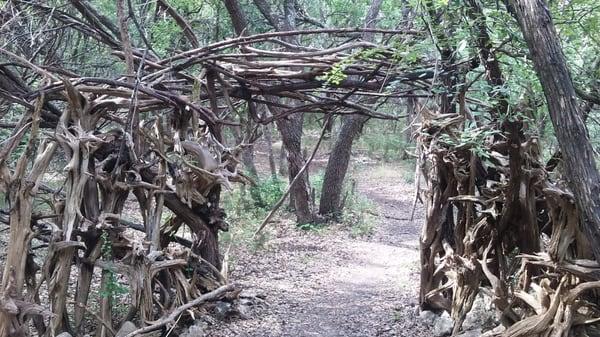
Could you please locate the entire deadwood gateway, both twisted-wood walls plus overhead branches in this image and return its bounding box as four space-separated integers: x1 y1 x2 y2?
0 1 600 336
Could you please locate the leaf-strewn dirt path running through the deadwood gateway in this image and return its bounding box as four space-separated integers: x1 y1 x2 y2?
208 167 429 337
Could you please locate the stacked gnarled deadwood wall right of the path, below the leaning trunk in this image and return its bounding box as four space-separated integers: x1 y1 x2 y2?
418 75 600 337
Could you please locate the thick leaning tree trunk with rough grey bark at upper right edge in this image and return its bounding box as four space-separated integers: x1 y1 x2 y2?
509 0 600 261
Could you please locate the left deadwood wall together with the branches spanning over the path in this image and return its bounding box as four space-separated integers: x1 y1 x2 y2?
0 1 426 336
